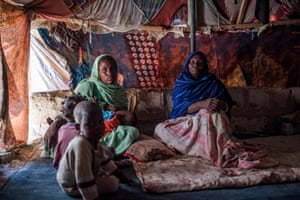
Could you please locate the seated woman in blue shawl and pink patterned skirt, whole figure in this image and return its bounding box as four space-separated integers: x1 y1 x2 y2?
154 51 277 169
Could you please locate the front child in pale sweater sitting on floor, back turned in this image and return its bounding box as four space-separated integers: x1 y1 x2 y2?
56 101 131 199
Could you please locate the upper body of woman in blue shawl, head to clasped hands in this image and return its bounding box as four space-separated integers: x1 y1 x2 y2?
170 51 233 119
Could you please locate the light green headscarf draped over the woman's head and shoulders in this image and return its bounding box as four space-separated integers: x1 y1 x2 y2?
74 54 128 110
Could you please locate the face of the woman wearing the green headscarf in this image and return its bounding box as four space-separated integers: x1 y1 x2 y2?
98 60 118 84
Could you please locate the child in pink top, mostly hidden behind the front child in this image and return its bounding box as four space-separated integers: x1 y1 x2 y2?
53 94 86 169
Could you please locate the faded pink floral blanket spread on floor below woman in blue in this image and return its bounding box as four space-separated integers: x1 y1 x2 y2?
134 135 300 193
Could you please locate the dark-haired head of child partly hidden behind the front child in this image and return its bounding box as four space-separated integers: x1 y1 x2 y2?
61 94 86 122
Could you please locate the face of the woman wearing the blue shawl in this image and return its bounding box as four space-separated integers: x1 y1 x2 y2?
189 55 207 79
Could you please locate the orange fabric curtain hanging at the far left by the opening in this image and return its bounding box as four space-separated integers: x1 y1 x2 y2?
0 4 30 143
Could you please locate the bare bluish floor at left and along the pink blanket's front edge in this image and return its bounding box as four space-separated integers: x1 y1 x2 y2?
0 137 300 200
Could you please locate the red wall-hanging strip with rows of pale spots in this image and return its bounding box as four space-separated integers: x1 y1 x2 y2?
125 31 165 88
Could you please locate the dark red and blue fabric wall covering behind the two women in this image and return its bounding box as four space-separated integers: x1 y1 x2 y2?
37 22 300 88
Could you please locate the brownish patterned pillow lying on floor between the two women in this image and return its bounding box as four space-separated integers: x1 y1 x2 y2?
123 139 176 162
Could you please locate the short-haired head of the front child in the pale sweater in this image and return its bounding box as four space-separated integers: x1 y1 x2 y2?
74 100 104 141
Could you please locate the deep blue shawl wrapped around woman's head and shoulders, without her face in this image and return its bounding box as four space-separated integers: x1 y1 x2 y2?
169 51 233 119
